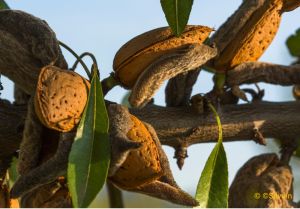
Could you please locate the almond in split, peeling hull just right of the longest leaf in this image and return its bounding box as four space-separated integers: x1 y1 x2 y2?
108 104 198 206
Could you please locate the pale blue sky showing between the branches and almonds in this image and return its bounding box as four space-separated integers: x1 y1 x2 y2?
1 0 300 206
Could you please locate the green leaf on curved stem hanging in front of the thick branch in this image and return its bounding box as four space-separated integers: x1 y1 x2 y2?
195 103 228 208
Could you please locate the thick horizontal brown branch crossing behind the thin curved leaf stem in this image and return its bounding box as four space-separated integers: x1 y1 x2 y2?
131 102 300 147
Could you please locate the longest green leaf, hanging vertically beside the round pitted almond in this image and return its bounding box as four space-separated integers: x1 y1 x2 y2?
68 70 110 207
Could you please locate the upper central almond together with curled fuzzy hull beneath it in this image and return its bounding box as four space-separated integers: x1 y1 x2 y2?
113 25 217 107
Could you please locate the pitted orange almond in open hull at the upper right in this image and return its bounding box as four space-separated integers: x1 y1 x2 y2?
212 0 283 71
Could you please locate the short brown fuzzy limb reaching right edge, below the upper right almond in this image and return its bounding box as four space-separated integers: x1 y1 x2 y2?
227 62 300 86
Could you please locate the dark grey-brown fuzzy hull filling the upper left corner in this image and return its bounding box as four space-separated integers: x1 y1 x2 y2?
0 9 67 95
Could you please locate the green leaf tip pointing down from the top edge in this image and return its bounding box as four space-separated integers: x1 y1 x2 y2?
160 0 194 36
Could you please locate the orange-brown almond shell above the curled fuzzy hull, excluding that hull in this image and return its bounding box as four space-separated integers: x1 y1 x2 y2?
113 25 212 88
